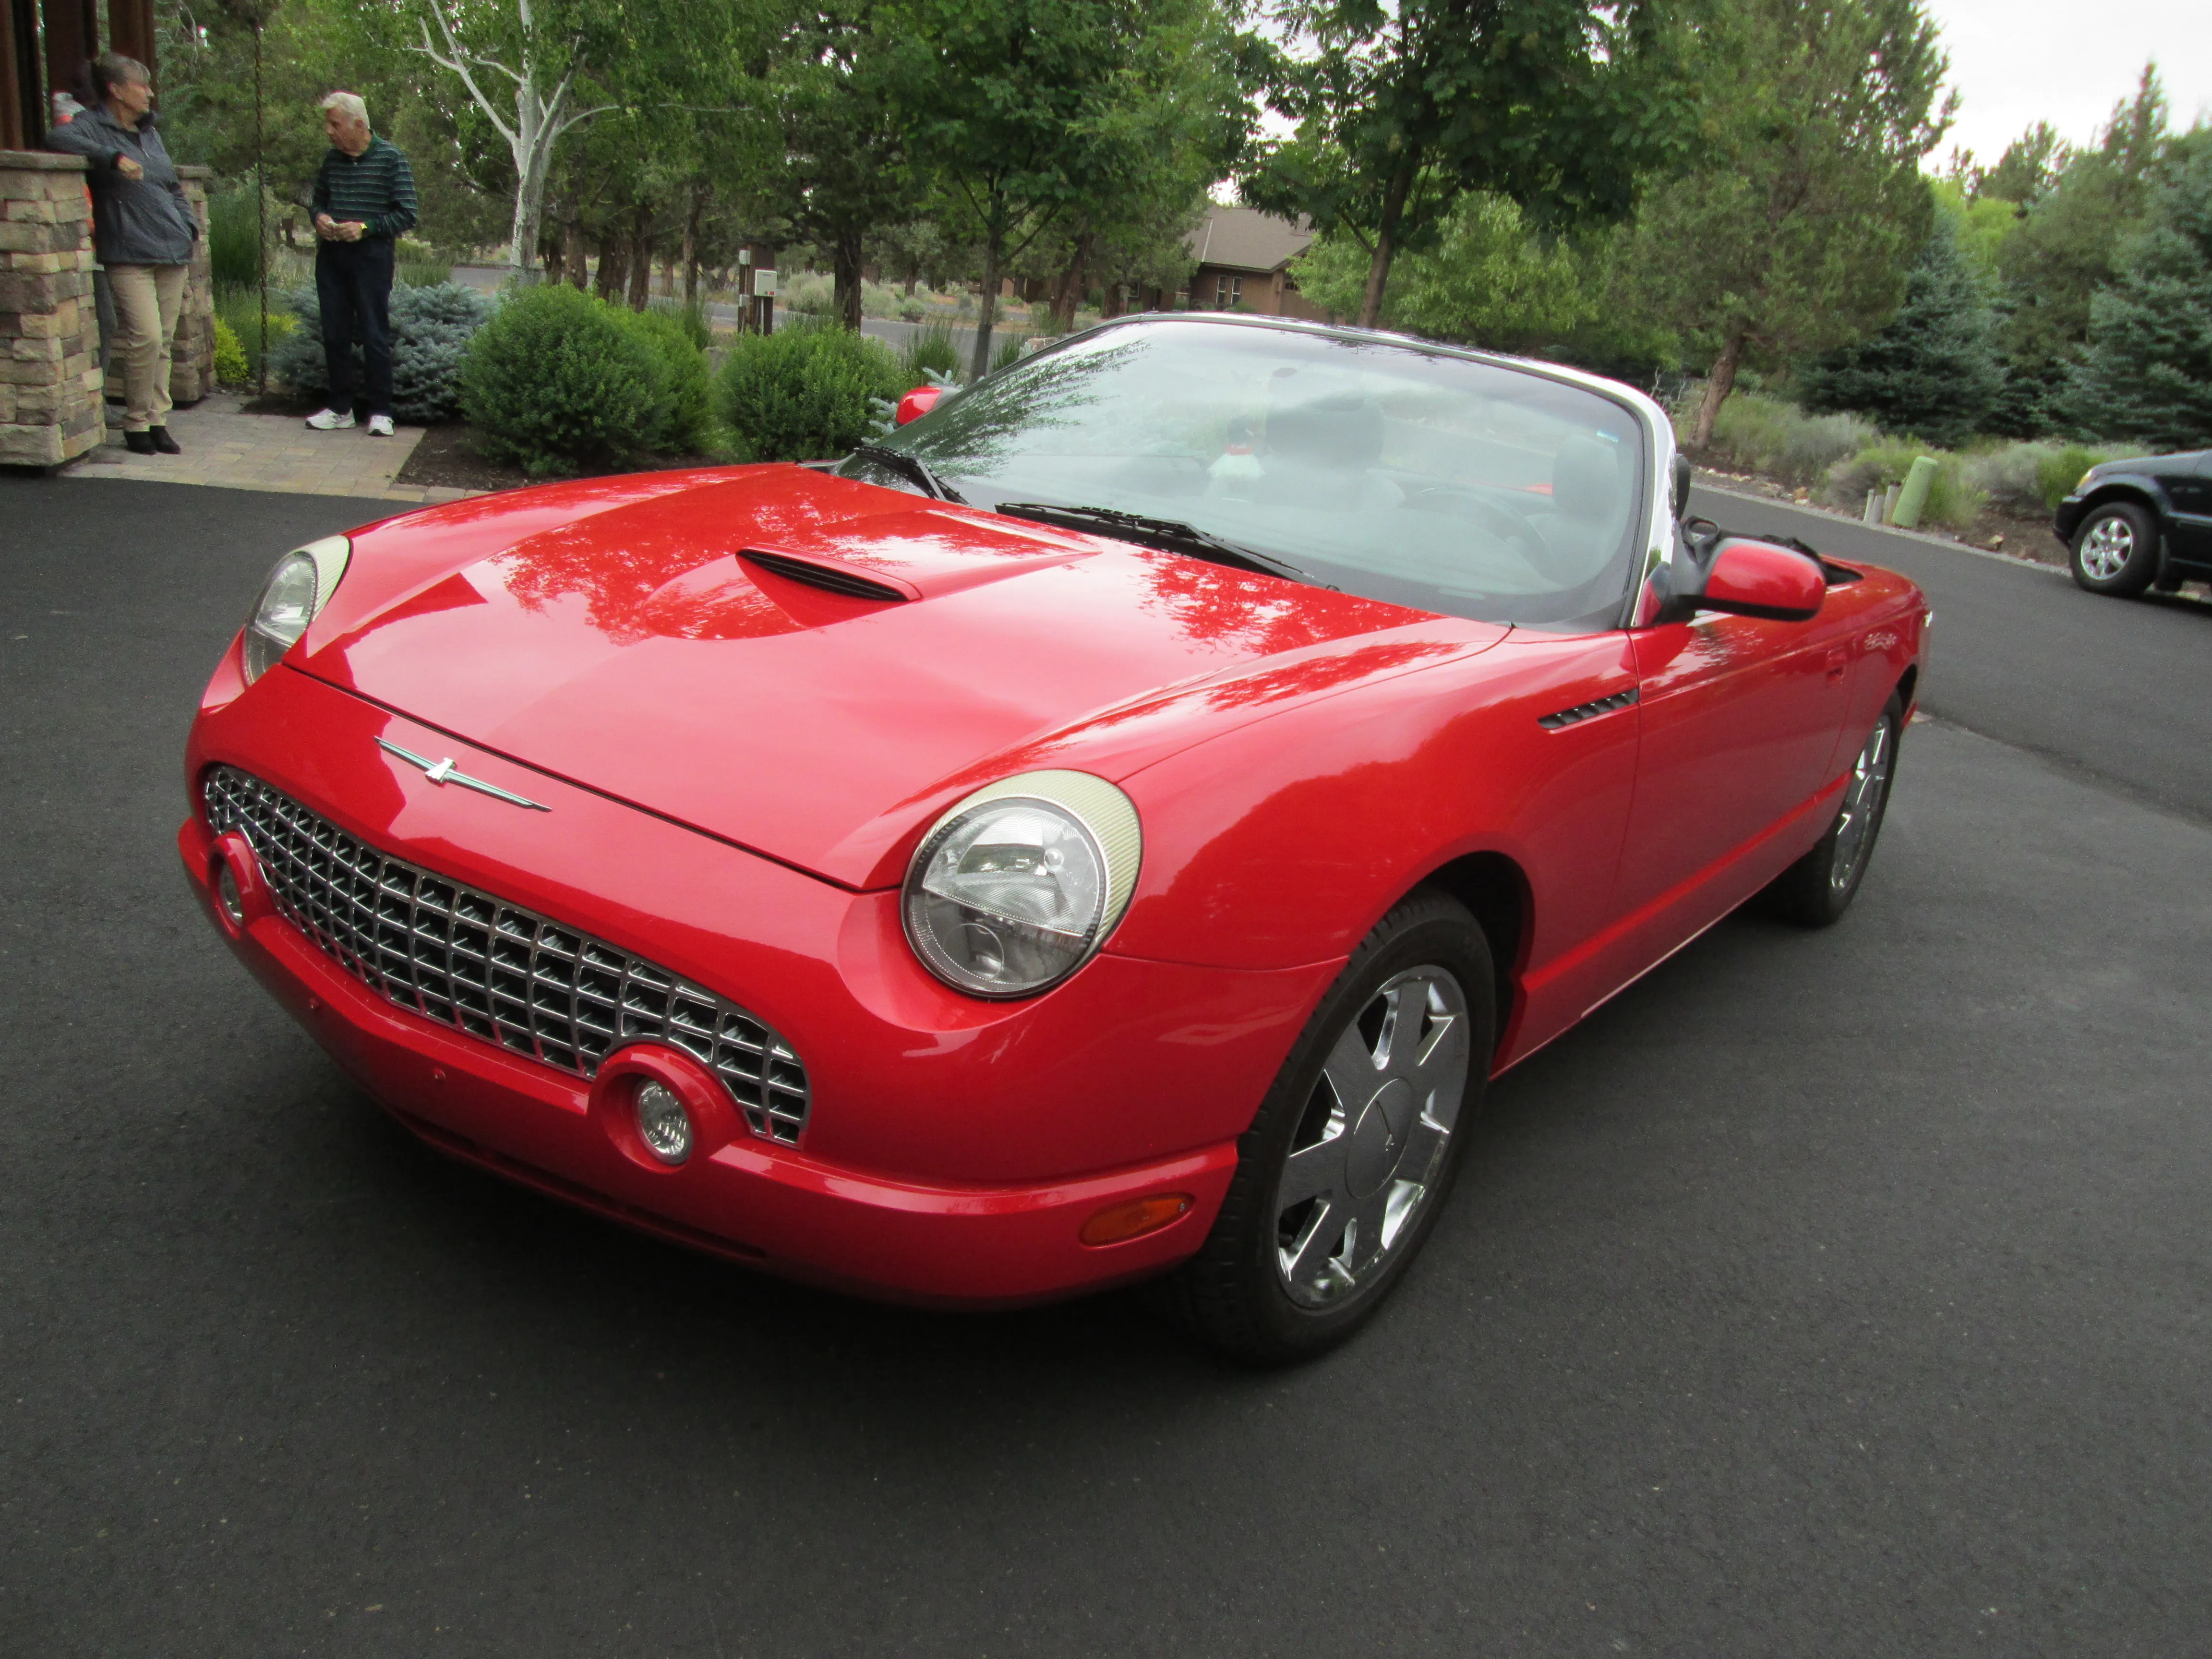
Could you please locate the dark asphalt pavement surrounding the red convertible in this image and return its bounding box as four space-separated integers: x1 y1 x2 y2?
0 480 2212 1659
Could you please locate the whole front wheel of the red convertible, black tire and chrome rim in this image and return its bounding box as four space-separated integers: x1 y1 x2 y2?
1161 891 1498 1365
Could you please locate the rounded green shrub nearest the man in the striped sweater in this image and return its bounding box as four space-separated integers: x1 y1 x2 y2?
460 283 666 478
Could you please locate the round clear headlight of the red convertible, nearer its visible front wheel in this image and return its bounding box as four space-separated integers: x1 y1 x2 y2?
900 772 1143 998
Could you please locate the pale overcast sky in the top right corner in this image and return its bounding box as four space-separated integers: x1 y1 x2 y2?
1927 0 2212 166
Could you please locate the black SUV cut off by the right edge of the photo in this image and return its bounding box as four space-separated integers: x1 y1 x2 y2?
2057 449 2212 597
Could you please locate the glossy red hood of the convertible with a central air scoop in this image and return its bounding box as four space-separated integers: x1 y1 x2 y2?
292 467 1506 887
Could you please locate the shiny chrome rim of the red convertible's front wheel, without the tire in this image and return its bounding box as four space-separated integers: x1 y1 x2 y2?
1274 967 1471 1307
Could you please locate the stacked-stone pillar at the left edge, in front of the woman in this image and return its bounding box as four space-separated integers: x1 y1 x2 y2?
0 150 106 467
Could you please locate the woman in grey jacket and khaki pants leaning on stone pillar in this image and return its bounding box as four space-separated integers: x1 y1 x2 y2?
47 53 199 456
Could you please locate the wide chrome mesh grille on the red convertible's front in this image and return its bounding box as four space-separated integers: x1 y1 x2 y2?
201 765 807 1146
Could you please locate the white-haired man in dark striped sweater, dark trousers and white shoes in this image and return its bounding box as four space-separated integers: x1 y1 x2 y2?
308 93 416 438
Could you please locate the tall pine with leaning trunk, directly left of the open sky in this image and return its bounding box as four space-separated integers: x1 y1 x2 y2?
1622 0 1949 449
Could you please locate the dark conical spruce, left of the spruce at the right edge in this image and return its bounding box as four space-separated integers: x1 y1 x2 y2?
1798 212 2002 449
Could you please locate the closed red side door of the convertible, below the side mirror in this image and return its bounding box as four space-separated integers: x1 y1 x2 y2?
1615 586 1858 971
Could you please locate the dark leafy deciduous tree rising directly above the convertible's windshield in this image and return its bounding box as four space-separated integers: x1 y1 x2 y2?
1243 0 1681 327
